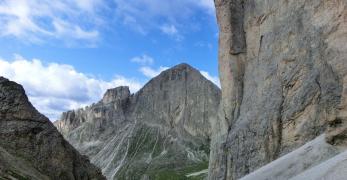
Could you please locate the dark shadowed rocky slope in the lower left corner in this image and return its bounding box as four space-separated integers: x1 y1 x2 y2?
0 77 105 180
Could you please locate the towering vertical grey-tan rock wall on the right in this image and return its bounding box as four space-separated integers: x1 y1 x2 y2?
209 0 347 179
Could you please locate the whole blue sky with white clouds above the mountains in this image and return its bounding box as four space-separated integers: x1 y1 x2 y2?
0 0 219 121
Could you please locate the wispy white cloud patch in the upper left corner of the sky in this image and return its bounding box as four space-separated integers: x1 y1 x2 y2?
0 0 103 43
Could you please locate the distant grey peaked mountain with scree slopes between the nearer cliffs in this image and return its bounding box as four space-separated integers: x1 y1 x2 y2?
55 64 220 179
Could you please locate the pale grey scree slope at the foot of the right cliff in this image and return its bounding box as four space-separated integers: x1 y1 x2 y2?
240 134 347 180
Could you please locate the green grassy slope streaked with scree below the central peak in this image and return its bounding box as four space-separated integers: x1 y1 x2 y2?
115 125 208 180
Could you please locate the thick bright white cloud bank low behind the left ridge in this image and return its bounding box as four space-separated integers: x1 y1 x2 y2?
0 56 142 120
